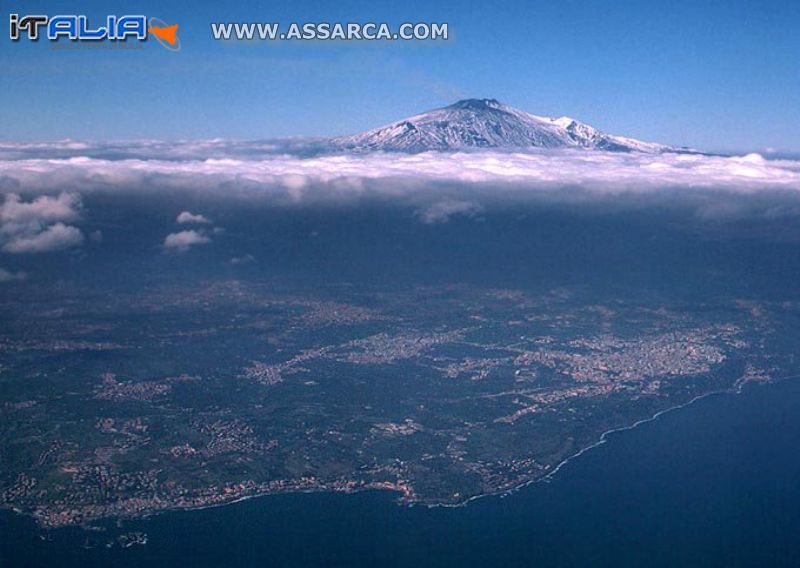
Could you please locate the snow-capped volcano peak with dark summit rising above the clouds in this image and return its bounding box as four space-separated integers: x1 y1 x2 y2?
331 99 692 153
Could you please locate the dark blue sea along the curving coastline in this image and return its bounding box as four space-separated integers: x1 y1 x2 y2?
0 380 800 567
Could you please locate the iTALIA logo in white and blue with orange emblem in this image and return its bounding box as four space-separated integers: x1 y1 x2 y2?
9 14 181 51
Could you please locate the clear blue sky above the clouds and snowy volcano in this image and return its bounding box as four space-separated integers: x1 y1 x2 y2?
0 0 800 152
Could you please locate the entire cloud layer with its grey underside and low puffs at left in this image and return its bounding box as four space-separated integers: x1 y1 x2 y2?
0 141 800 268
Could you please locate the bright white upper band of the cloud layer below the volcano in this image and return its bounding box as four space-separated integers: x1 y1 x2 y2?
0 143 800 201
